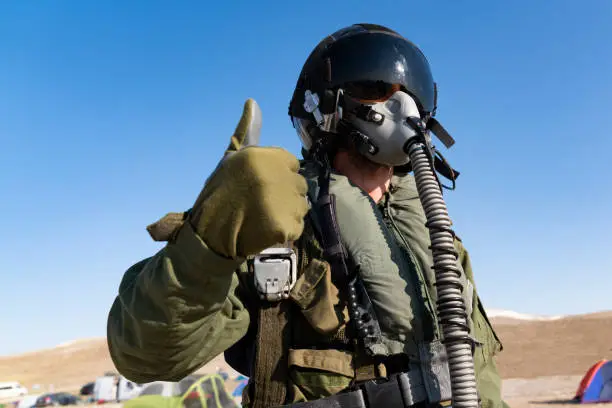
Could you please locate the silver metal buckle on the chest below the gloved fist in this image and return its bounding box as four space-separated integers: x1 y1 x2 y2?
252 247 297 302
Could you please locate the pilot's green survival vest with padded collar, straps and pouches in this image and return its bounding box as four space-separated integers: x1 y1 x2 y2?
225 162 501 408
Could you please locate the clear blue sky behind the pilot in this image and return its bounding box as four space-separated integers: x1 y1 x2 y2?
0 0 612 354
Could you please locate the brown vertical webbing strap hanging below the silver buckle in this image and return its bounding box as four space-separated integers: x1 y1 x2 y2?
250 301 291 408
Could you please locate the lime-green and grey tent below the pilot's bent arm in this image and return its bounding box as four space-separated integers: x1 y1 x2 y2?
123 374 238 408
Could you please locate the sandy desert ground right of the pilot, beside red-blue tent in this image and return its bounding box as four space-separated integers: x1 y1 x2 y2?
491 312 612 408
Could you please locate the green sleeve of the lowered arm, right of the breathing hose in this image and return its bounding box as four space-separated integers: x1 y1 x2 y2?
455 239 509 408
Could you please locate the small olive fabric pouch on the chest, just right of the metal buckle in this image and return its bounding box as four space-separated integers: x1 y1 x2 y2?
290 259 345 335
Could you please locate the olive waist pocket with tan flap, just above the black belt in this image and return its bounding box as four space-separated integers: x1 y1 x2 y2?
289 349 355 403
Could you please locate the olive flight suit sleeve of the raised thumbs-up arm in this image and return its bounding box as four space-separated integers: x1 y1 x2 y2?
107 223 249 383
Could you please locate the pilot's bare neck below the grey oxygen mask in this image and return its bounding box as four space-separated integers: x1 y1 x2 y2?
333 150 393 203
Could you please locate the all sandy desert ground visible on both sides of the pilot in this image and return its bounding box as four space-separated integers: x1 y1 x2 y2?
0 312 612 408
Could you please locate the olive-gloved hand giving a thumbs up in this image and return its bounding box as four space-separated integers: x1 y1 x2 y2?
187 99 308 258
